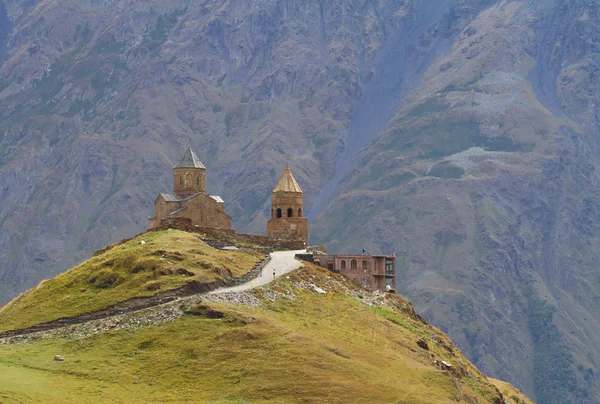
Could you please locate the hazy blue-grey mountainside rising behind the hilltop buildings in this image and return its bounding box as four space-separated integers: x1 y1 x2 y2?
0 0 600 403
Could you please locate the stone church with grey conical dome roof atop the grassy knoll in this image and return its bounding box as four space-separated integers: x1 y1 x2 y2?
149 147 231 229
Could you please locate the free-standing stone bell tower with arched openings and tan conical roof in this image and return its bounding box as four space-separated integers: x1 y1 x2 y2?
267 167 308 245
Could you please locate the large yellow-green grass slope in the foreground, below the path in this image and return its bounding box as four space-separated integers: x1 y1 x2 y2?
0 265 530 403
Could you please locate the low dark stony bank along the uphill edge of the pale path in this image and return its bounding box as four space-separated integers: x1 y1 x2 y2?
0 255 271 338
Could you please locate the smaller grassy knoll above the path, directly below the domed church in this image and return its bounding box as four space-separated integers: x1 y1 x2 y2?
0 230 263 332
